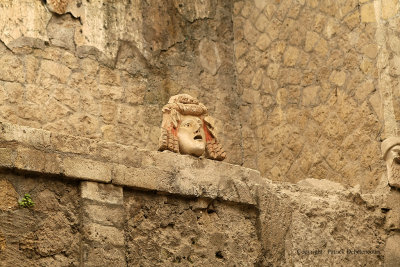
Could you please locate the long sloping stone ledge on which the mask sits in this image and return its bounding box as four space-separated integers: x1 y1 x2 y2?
0 122 263 205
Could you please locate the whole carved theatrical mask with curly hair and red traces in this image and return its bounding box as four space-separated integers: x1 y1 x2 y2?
158 94 226 160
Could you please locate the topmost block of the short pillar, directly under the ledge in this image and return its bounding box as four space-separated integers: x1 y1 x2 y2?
81 181 123 205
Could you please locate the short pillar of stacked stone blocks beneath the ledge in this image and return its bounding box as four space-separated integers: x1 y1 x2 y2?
81 181 125 266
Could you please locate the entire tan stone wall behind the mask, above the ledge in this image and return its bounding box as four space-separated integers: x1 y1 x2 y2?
0 0 400 191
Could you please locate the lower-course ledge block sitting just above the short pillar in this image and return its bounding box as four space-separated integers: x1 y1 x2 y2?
62 157 111 183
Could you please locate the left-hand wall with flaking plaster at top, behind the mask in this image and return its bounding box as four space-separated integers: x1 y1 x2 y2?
0 0 242 164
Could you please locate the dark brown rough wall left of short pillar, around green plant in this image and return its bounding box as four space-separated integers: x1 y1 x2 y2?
0 173 81 267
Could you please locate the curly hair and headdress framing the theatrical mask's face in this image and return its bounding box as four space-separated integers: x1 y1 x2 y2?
158 94 226 160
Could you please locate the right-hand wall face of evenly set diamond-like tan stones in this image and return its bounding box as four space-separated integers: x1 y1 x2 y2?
233 0 400 193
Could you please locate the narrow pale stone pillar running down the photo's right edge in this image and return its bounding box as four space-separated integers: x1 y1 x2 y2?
374 0 400 266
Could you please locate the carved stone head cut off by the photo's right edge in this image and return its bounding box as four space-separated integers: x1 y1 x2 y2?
381 137 400 189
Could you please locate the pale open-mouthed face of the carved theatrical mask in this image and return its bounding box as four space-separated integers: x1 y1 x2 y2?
178 115 206 157
